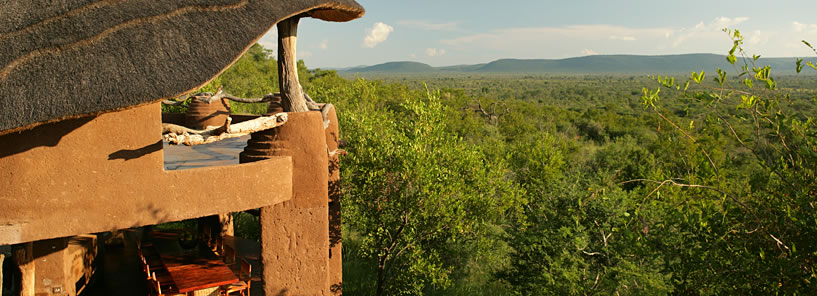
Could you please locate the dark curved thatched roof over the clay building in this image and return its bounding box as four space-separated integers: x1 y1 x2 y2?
0 0 364 134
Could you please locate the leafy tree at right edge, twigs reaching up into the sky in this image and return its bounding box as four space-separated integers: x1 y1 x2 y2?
643 30 817 294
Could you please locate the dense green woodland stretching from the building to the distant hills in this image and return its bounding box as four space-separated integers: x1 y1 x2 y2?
164 45 817 295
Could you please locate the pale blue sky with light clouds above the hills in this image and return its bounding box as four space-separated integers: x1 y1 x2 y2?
259 0 817 68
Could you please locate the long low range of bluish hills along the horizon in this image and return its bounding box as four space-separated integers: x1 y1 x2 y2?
340 54 808 74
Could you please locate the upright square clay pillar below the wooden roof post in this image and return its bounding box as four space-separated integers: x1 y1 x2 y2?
241 112 331 295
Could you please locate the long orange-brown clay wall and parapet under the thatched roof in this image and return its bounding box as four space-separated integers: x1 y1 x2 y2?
0 103 293 245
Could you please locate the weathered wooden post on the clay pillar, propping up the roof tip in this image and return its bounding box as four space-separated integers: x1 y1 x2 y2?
278 16 309 112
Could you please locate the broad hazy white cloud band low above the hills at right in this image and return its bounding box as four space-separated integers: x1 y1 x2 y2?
428 16 817 60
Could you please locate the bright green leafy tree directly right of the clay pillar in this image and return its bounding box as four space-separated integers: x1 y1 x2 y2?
341 82 519 295
